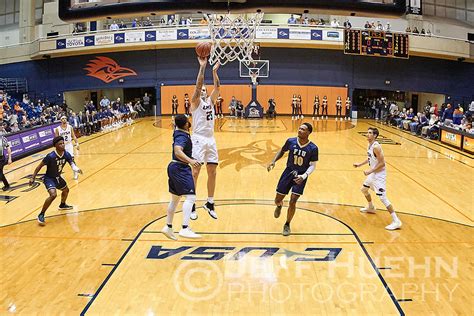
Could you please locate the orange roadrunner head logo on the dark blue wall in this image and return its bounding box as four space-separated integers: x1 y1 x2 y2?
84 56 137 83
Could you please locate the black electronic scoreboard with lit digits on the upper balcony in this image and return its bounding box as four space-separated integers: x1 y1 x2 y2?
344 29 409 58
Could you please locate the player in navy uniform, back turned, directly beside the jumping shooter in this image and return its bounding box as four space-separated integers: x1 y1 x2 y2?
161 114 201 240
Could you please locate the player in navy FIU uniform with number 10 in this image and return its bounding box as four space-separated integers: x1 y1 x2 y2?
267 123 318 236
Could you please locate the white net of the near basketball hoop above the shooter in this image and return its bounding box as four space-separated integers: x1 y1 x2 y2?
205 13 263 65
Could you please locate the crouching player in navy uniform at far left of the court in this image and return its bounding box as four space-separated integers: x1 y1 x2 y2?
30 136 82 226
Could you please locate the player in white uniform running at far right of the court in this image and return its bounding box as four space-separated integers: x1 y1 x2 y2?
354 127 402 230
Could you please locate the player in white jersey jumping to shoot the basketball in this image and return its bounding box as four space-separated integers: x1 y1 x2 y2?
191 57 220 220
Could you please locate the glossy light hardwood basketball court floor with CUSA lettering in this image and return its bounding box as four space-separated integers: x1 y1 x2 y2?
0 117 474 315
